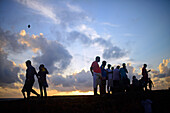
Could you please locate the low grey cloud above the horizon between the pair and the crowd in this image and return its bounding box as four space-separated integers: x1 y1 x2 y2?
50 70 92 91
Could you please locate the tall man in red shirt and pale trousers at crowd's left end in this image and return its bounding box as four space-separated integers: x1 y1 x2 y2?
90 56 101 95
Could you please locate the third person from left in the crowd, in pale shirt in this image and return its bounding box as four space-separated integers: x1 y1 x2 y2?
106 64 113 94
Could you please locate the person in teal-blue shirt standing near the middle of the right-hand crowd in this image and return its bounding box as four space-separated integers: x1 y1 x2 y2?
120 63 129 91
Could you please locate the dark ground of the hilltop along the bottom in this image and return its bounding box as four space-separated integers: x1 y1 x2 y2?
0 90 170 113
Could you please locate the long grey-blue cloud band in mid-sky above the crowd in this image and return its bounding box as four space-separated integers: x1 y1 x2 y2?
67 28 127 59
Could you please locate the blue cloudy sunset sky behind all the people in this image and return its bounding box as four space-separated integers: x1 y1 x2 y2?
0 0 170 98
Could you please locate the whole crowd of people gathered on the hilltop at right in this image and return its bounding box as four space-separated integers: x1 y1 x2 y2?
90 56 153 95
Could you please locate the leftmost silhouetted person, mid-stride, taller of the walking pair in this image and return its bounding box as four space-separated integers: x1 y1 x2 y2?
22 60 40 99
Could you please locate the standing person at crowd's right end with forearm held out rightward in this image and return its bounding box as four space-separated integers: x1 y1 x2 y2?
142 64 151 91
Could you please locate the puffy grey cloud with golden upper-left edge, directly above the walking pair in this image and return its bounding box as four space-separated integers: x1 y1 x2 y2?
20 29 72 73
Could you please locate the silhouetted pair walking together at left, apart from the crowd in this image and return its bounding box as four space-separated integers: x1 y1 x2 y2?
22 60 48 99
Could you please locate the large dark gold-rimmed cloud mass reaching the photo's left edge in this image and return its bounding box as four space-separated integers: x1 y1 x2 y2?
0 29 72 86
